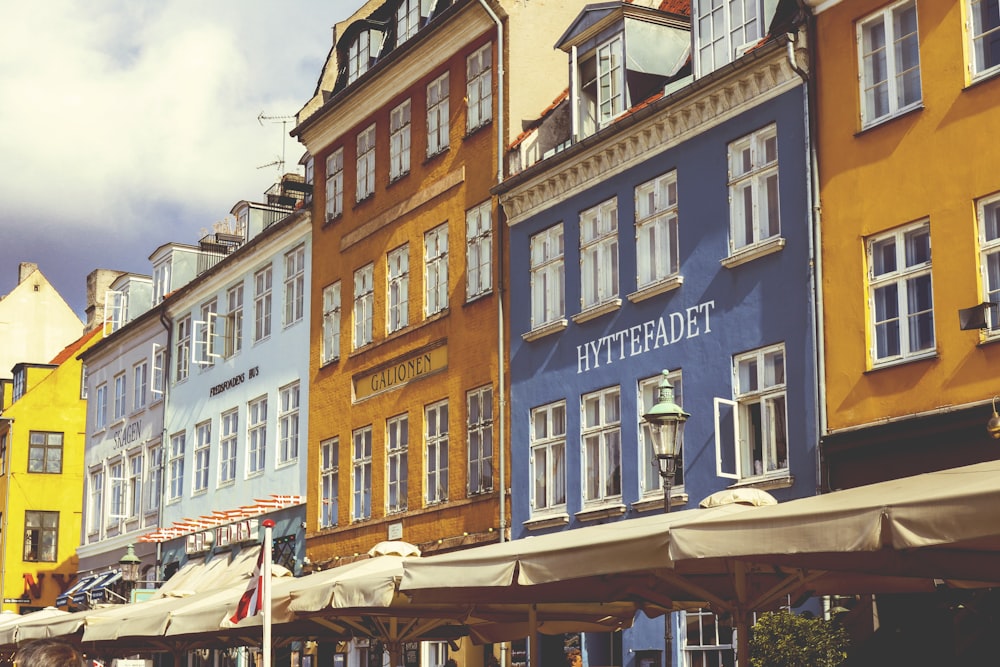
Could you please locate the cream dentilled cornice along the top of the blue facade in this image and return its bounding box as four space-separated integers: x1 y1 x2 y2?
500 45 802 226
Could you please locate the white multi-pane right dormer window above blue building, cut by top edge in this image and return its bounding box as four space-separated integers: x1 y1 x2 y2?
691 0 767 78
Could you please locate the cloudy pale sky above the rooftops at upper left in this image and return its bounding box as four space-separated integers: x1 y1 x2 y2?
0 0 363 319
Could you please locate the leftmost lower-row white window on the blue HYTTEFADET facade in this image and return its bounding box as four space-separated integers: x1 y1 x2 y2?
531 401 566 513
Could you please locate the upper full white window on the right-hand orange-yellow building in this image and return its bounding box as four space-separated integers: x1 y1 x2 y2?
858 0 921 127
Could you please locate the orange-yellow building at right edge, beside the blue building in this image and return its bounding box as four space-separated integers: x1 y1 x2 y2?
808 0 1000 488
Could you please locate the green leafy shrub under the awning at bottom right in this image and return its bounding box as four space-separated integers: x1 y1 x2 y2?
750 611 849 667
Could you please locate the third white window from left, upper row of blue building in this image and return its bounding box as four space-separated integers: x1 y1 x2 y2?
635 171 680 289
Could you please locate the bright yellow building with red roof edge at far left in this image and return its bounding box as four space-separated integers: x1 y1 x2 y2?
0 328 100 613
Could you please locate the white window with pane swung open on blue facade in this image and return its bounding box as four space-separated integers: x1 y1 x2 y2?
715 343 788 480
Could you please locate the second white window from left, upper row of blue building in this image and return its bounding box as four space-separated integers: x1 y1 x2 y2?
580 199 618 310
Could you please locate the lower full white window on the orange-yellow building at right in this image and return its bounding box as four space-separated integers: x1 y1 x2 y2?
867 221 934 365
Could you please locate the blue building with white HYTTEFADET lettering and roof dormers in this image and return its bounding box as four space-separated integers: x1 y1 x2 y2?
497 1 818 667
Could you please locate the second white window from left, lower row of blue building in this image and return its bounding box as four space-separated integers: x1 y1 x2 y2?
580 387 622 503
